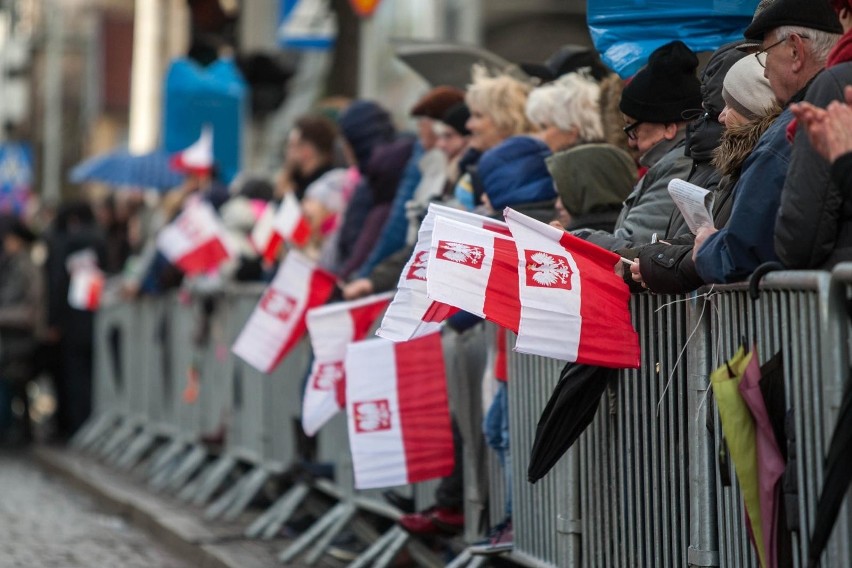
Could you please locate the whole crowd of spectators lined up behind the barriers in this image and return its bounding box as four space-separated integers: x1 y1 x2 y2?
0 0 852 560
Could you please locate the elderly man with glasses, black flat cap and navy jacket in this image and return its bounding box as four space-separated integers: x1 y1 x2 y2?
693 0 841 283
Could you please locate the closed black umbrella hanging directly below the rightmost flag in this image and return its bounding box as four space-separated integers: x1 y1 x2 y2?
527 363 618 483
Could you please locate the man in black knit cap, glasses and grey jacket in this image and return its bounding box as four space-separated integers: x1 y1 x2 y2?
574 41 701 251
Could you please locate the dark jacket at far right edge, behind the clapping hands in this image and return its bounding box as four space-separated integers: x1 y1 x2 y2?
774 63 852 269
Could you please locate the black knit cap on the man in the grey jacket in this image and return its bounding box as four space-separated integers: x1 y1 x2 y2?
618 41 701 124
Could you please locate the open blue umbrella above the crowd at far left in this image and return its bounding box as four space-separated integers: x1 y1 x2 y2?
70 149 183 190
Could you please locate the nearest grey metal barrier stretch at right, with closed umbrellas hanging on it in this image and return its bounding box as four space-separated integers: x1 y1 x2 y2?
500 265 852 567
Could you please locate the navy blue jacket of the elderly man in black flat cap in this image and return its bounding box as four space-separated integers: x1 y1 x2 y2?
695 108 793 284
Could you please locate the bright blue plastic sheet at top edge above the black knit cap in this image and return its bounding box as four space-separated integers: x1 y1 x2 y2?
587 0 758 78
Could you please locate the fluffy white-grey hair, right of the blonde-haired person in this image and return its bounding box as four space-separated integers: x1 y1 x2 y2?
526 71 604 142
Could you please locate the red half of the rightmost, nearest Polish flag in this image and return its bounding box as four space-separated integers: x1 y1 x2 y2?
559 233 640 369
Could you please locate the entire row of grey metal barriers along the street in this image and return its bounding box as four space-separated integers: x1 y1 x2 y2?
78 265 852 567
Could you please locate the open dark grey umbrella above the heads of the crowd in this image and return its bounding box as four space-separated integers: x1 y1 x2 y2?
393 40 511 89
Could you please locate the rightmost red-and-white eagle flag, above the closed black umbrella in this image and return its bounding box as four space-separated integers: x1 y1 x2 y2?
503 207 639 369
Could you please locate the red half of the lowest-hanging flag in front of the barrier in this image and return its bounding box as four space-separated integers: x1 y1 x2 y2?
394 333 455 483
